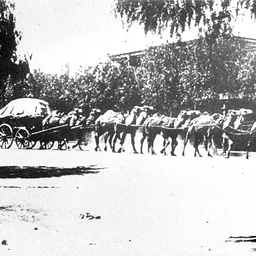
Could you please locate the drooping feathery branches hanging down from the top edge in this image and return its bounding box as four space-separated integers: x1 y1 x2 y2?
114 0 256 41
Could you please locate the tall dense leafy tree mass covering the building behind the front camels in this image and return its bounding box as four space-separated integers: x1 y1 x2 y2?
133 37 256 114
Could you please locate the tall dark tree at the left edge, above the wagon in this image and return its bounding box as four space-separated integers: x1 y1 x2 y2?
0 0 29 106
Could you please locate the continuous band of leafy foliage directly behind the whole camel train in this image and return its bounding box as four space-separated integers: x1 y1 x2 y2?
15 34 256 115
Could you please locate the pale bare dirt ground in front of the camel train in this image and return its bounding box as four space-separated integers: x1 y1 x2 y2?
0 133 256 256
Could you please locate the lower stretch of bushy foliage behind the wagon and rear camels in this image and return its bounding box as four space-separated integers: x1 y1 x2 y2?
23 62 141 113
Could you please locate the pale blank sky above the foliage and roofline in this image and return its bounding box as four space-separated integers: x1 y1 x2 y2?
14 0 256 74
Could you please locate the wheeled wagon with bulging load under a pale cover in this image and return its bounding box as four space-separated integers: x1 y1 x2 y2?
0 98 81 149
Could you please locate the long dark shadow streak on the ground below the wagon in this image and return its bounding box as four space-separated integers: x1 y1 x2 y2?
0 165 103 179
